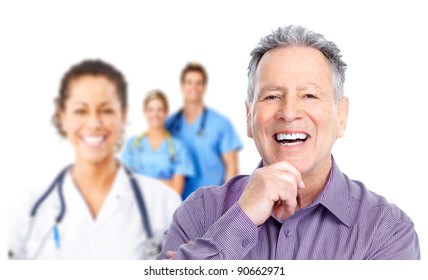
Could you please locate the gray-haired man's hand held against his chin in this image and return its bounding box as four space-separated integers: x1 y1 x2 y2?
238 161 305 226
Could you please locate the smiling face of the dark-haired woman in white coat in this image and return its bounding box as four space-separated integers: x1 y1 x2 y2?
59 75 125 163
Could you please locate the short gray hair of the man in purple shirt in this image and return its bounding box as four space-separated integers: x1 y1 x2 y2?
247 25 346 104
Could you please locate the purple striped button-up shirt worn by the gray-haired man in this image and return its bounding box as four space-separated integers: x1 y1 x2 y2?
158 159 420 260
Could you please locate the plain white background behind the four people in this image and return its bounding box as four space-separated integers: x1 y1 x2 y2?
0 0 428 276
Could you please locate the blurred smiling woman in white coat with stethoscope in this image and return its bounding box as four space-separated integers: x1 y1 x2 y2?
9 60 181 259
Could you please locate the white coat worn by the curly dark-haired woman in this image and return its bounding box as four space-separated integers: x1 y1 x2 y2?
9 167 181 259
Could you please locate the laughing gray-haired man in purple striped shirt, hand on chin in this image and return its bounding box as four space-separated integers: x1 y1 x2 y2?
159 26 420 259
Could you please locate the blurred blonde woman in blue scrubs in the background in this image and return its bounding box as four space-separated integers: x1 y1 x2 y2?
121 90 194 194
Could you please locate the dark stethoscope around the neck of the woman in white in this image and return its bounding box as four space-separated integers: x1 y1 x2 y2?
27 166 161 259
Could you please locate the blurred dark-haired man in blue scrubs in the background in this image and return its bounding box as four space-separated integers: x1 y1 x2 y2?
165 63 242 199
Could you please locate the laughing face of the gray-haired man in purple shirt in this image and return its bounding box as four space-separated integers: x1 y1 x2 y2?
247 47 348 177
